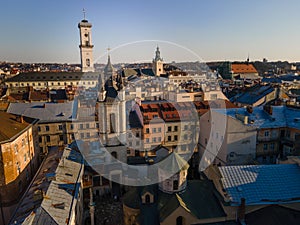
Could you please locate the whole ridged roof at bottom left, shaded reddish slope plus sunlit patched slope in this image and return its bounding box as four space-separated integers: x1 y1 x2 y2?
13 148 83 224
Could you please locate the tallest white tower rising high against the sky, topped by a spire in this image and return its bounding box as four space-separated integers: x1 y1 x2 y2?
78 10 95 72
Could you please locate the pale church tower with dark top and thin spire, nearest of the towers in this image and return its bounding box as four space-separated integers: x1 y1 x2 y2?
97 55 126 162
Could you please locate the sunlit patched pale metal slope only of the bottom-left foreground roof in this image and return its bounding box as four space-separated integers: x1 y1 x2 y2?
19 149 83 225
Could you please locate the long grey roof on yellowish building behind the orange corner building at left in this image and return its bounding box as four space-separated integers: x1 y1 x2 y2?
7 101 77 123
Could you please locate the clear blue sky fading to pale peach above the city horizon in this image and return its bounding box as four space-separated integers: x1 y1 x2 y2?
0 0 300 63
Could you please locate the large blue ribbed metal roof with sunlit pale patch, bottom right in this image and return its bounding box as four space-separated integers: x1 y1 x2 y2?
219 164 300 205
